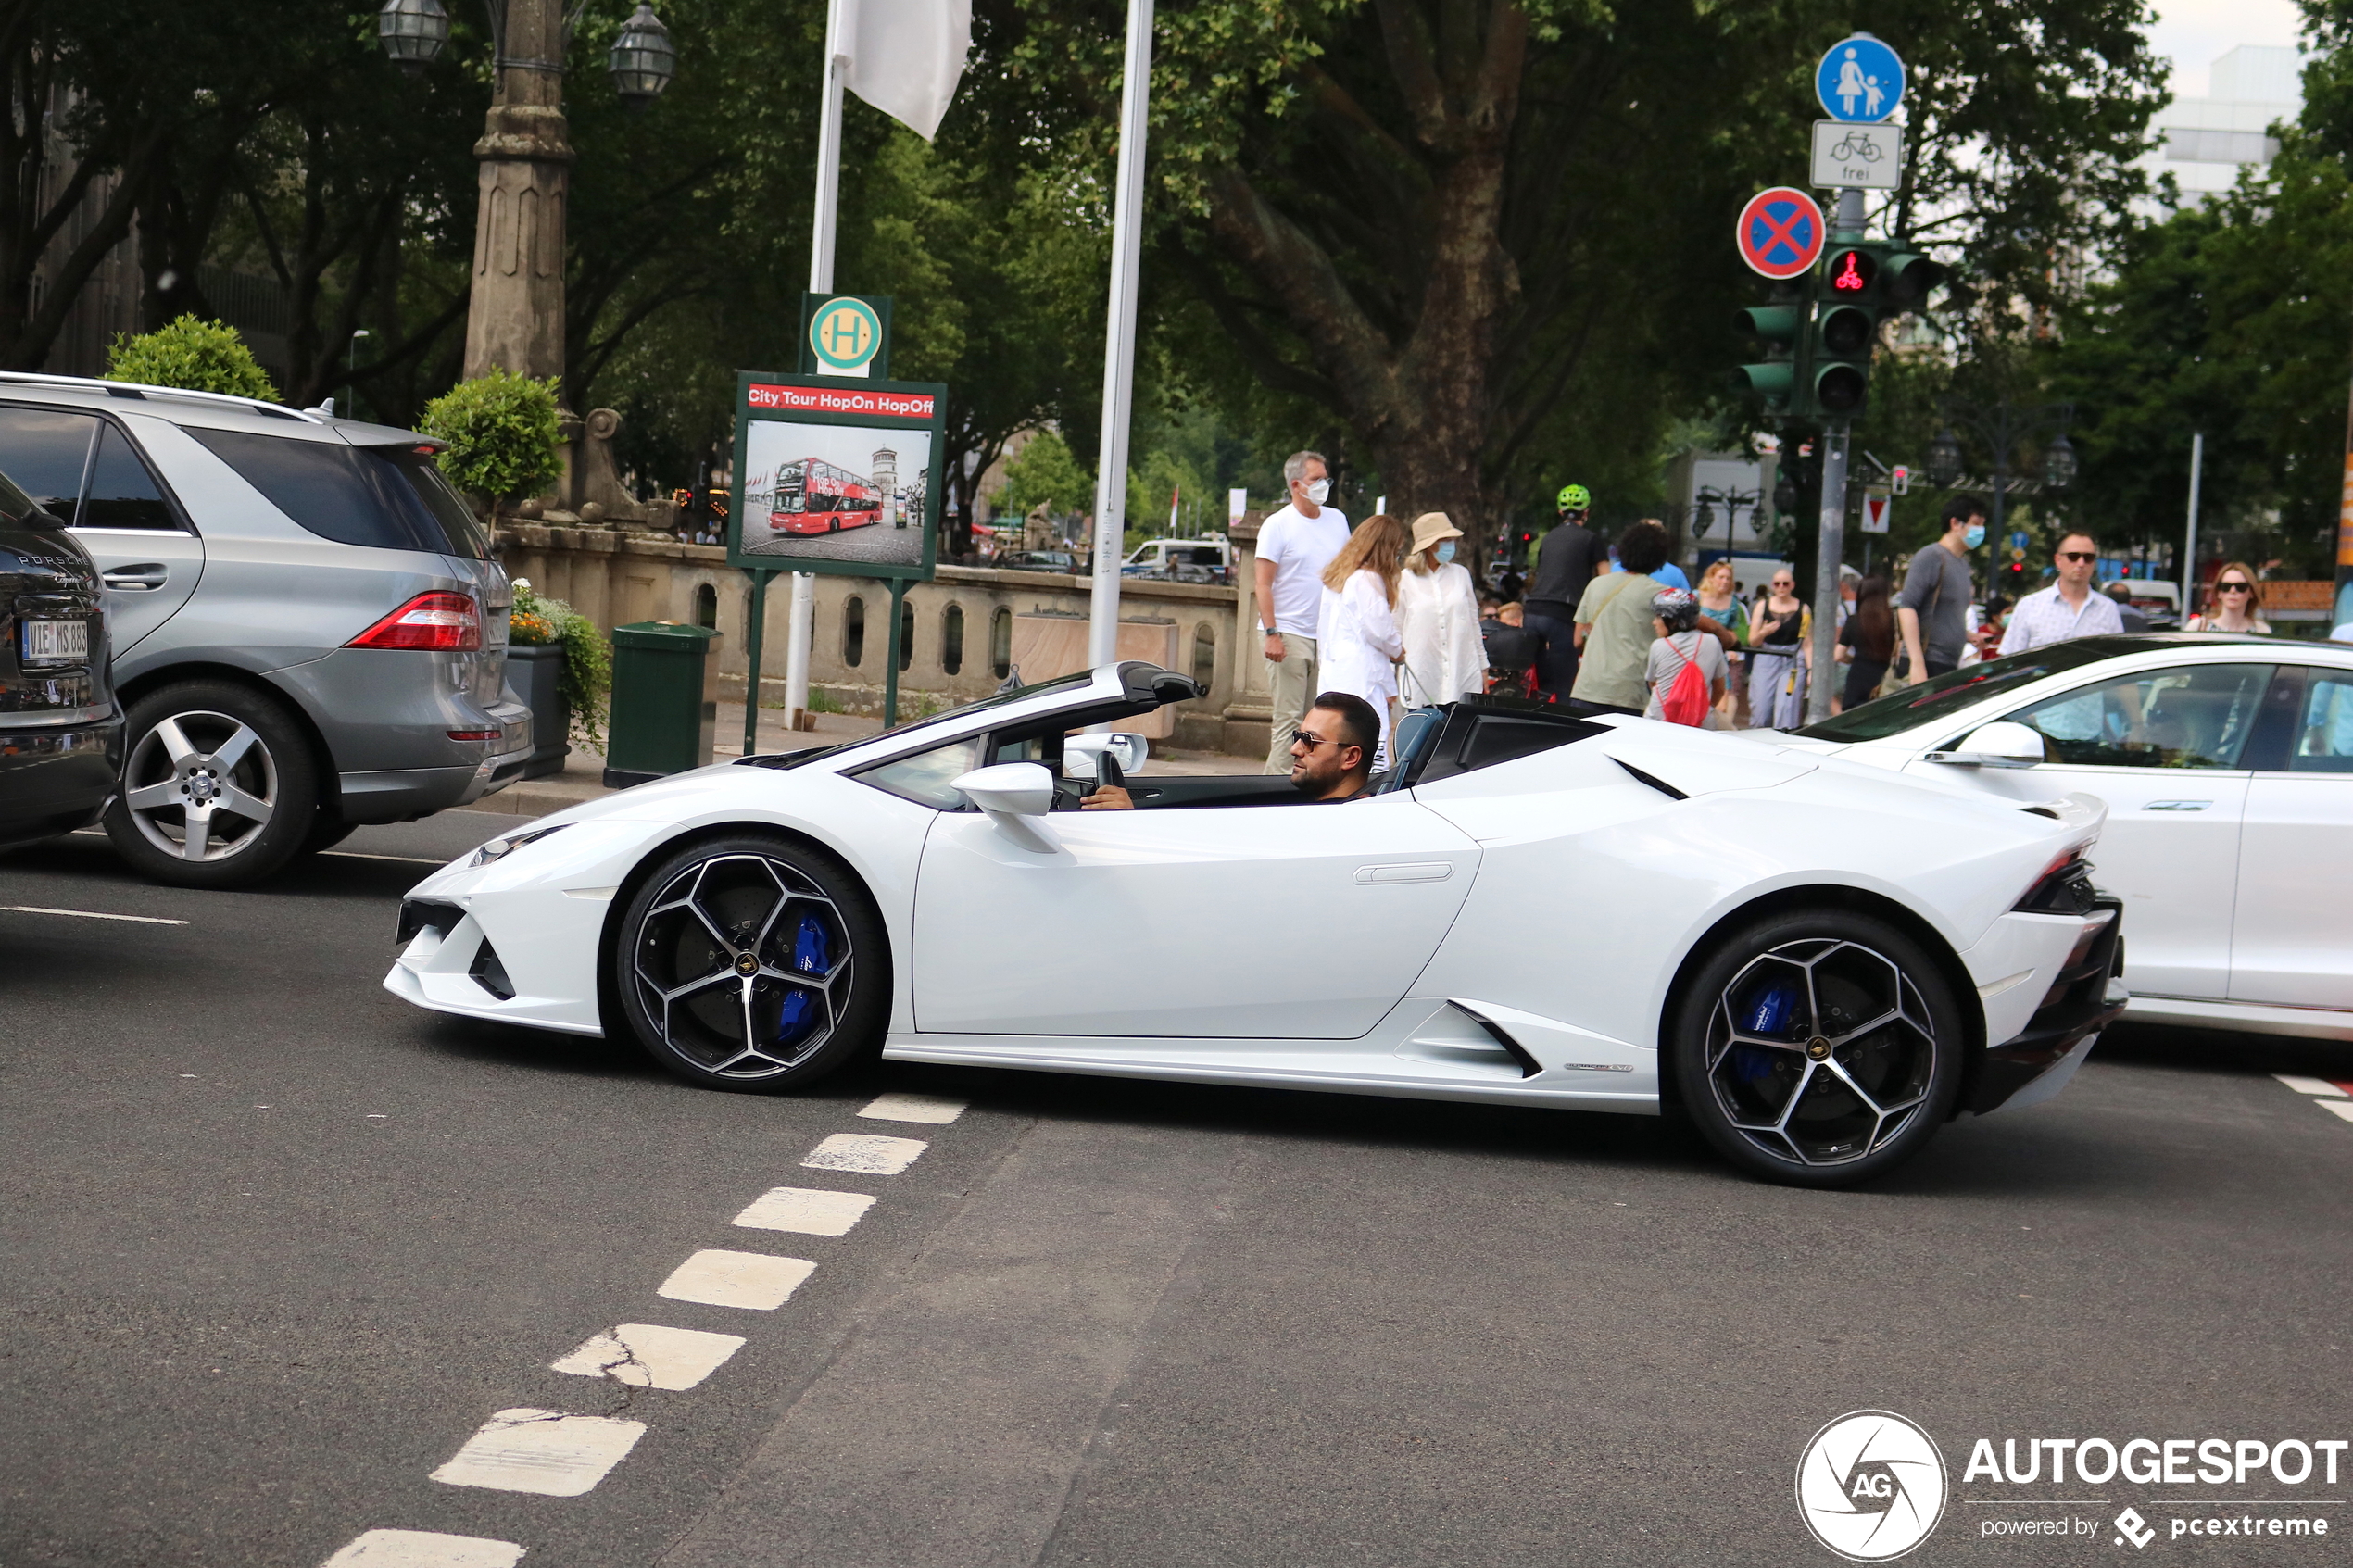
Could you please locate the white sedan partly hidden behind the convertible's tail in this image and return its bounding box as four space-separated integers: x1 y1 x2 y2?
1777 633 2353 1039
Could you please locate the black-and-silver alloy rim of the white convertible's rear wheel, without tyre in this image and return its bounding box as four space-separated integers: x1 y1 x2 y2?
1706 938 1936 1166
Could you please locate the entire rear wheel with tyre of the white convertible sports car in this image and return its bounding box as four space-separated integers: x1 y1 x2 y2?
1670 909 1965 1187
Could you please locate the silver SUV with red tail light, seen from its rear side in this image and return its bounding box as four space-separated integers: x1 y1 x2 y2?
0 371 532 886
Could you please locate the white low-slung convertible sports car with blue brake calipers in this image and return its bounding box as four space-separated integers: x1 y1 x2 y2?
386 663 2125 1187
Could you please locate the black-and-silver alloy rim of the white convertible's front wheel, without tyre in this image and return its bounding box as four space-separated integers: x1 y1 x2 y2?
631 853 857 1079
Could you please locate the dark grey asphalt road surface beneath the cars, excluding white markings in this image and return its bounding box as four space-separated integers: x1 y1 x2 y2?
0 813 2353 1568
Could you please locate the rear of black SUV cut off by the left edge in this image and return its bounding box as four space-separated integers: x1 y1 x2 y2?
0 475 122 848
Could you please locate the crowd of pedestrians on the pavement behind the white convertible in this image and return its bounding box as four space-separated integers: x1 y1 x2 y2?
1256 451 2271 773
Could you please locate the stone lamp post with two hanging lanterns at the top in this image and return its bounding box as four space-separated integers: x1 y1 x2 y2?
376 0 678 379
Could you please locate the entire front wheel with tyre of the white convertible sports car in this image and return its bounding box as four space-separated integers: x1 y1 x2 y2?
614 834 889 1093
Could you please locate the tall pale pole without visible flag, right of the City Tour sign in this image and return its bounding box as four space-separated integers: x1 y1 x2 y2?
1087 0 1153 665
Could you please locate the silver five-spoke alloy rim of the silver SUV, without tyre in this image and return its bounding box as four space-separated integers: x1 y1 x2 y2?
122 710 278 863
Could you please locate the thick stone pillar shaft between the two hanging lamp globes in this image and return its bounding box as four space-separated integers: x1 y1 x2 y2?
466 0 572 379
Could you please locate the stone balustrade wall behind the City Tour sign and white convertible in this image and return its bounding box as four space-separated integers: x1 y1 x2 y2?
497 521 1266 755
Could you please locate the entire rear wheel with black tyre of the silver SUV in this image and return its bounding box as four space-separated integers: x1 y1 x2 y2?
106 682 318 888
